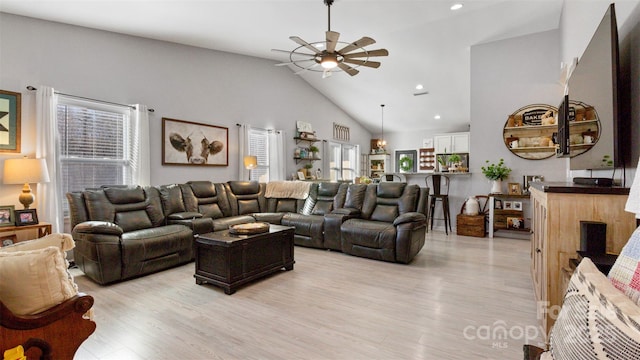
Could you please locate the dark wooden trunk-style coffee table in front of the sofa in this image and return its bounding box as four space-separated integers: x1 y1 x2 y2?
194 225 295 295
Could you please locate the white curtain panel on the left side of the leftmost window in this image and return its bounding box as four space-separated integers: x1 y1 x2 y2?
36 85 64 232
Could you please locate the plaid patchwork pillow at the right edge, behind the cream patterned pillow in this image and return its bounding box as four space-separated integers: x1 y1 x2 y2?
609 227 640 305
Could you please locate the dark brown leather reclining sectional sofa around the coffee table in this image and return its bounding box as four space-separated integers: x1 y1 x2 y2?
67 181 428 284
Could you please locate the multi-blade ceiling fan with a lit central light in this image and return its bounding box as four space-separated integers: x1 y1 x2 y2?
272 0 389 78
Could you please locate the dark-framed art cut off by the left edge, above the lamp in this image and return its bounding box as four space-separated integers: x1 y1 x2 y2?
0 90 22 153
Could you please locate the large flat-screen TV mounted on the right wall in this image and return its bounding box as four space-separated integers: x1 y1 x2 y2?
558 4 628 170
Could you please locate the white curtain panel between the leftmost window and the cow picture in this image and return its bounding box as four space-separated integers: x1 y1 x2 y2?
130 104 151 186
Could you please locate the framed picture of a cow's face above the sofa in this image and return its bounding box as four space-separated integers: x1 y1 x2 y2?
162 118 229 166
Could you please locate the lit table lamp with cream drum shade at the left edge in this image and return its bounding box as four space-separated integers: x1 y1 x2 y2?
4 157 49 209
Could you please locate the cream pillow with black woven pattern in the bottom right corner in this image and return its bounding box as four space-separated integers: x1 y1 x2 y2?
542 258 640 360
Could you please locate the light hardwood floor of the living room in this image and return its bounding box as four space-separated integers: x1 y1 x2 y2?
73 232 542 360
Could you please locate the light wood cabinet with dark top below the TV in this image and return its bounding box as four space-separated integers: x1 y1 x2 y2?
530 187 635 333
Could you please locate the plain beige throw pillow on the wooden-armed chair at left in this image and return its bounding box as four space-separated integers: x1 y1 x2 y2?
0 246 78 315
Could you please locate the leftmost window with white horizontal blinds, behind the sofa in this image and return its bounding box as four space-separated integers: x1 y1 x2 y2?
57 97 132 214
